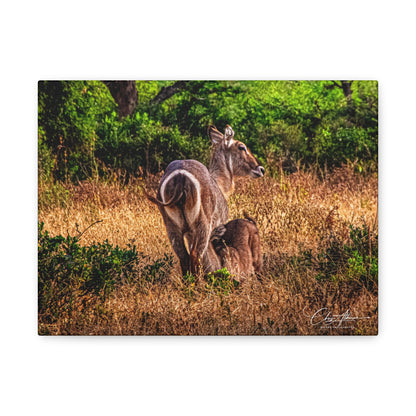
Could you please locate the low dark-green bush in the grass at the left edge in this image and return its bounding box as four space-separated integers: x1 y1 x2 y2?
38 223 173 320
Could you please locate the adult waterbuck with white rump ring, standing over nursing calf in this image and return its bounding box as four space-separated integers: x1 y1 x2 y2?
147 125 264 274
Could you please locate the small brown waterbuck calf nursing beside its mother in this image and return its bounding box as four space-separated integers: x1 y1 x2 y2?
211 215 263 280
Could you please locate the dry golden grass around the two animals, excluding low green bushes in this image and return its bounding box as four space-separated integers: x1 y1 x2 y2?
39 166 378 335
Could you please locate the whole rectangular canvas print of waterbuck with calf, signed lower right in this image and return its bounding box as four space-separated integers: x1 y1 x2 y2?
38 80 378 336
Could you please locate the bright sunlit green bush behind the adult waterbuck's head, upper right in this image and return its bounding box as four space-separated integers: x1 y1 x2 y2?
143 81 378 171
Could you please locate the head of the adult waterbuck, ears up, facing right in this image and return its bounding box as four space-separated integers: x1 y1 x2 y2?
208 125 264 180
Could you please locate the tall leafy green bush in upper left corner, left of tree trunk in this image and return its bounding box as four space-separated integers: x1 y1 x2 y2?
38 81 116 180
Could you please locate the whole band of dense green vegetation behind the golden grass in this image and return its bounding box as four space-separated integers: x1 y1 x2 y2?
38 81 378 181
